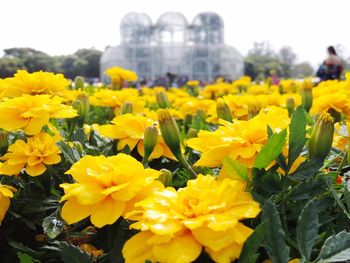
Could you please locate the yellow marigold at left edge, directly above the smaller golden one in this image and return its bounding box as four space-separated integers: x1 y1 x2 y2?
0 95 77 135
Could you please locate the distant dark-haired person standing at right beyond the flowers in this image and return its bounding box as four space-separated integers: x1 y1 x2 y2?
317 46 344 81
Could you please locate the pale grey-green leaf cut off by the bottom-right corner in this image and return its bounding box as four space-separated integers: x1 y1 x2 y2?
317 231 350 263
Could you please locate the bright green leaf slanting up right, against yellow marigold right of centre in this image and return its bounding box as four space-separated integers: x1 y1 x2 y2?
254 129 287 169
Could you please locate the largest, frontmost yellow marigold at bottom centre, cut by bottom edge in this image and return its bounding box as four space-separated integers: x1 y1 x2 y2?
123 175 260 263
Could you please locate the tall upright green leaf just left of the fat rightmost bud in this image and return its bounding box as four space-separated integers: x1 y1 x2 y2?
288 106 306 169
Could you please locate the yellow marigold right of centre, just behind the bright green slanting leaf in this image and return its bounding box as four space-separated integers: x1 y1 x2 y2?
187 107 290 168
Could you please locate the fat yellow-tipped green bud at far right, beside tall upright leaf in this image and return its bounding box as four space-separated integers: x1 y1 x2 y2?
309 112 334 159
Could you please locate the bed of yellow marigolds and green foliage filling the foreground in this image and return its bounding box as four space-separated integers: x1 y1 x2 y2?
0 68 350 263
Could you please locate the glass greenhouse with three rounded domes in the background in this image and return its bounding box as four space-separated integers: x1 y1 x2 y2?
101 12 244 82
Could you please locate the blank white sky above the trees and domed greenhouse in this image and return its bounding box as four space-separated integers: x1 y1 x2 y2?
0 0 350 66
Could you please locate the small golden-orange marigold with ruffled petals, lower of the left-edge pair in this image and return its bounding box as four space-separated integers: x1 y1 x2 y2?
0 132 61 176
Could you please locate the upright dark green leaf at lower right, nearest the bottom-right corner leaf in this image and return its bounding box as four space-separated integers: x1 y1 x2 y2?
297 200 319 260
